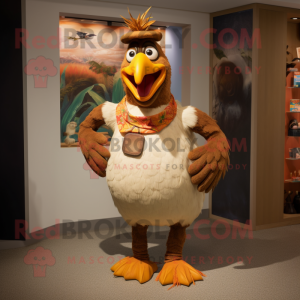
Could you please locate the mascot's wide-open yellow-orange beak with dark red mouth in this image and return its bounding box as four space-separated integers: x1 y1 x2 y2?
121 53 166 102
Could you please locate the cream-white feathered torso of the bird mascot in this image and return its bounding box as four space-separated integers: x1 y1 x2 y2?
102 102 204 226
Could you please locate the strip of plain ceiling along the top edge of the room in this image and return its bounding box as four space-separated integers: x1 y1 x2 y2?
91 0 300 13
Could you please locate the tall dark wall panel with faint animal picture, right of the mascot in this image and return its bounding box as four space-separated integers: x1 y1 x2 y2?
212 10 256 223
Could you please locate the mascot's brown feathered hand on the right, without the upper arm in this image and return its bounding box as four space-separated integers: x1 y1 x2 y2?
188 135 230 193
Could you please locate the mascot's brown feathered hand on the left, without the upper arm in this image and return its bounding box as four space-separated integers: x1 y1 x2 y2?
78 128 110 177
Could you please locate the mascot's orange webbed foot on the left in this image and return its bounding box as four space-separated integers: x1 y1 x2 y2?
111 257 157 283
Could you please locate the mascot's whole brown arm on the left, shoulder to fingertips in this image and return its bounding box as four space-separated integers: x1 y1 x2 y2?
78 104 110 177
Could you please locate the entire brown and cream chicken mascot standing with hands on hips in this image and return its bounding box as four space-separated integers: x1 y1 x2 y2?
79 9 229 286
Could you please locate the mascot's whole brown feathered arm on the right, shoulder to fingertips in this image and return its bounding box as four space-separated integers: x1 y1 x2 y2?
188 108 230 193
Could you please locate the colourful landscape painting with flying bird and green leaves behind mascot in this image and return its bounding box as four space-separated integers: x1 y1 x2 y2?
59 17 165 147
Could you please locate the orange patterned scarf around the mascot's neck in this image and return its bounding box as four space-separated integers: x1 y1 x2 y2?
116 95 177 134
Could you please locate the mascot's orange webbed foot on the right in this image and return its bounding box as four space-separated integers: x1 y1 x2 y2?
155 260 206 290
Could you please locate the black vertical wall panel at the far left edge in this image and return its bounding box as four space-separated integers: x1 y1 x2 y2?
0 0 25 240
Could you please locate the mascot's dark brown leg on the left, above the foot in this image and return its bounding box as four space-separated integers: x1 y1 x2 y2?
132 224 149 261
